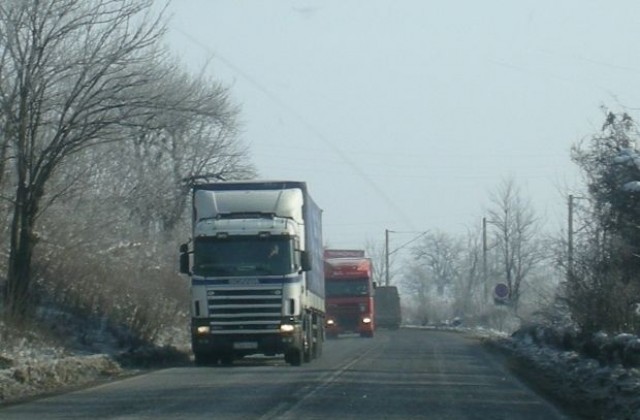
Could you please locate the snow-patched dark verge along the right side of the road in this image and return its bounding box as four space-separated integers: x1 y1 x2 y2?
410 325 640 420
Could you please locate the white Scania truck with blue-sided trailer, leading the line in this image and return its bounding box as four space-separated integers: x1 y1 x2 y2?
180 181 325 366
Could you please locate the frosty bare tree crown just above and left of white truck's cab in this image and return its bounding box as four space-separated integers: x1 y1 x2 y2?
106 69 255 236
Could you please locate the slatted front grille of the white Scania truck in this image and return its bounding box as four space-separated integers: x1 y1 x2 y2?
207 287 282 334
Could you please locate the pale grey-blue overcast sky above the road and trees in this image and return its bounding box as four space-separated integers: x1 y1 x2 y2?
159 0 640 248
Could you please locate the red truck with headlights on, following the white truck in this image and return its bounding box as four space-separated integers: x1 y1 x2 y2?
324 249 375 338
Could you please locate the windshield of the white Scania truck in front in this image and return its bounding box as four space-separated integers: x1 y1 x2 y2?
193 236 295 276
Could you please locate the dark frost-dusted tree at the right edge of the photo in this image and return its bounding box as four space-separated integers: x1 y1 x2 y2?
566 112 640 331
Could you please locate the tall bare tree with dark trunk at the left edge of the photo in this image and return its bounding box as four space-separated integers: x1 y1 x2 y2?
0 0 164 318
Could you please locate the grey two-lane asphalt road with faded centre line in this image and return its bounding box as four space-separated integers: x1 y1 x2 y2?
0 329 569 420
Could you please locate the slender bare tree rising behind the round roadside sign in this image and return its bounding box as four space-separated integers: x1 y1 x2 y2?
489 178 543 314
